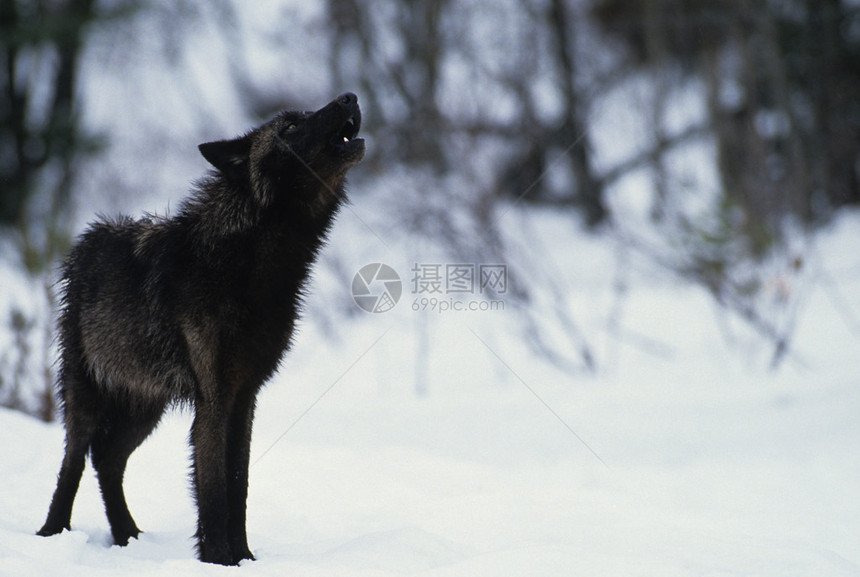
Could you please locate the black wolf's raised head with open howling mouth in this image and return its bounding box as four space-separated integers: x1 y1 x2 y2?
199 92 365 213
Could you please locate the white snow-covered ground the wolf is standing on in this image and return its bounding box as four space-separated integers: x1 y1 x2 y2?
0 201 860 577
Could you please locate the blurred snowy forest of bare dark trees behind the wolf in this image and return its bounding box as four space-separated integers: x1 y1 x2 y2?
5 0 860 420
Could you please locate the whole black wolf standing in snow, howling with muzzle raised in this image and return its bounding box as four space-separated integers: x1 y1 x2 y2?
39 93 365 565
